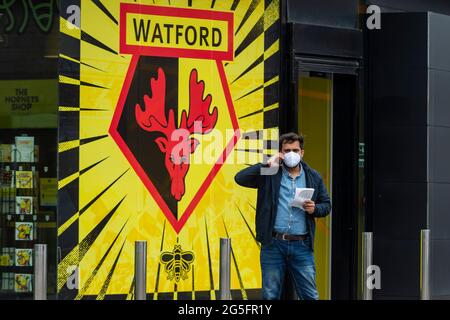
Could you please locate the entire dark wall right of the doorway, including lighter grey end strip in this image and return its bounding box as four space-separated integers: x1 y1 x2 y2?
367 13 450 299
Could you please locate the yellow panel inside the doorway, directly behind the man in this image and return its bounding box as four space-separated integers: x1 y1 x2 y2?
297 71 333 299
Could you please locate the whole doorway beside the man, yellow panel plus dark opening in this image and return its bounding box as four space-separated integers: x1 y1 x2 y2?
292 61 365 299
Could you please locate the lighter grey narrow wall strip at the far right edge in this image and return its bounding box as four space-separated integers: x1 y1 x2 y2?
428 13 450 299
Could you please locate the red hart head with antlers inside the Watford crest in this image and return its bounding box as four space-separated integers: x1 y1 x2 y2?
136 68 217 201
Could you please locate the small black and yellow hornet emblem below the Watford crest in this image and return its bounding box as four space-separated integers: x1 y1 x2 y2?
160 244 195 282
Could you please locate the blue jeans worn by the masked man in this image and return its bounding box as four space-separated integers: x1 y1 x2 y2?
261 237 319 300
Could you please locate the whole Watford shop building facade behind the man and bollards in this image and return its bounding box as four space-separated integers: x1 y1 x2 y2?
0 0 450 300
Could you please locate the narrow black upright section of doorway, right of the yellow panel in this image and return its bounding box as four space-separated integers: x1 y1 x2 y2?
331 74 362 299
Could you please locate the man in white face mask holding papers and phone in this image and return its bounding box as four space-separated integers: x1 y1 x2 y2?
235 133 331 300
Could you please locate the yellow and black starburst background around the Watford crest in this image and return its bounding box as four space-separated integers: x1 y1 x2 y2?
58 0 279 299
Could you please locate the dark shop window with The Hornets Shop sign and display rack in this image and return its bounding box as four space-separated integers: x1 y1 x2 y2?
0 0 58 299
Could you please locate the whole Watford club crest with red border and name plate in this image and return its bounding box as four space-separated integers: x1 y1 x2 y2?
109 4 240 233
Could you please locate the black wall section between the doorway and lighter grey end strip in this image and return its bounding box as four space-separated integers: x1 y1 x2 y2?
367 14 428 299
